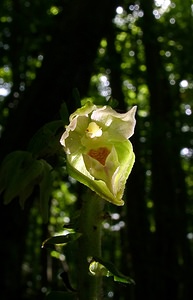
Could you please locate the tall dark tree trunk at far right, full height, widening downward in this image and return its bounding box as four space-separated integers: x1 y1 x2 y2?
141 0 193 300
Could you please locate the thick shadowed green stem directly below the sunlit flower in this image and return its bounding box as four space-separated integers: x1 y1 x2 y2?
79 191 104 300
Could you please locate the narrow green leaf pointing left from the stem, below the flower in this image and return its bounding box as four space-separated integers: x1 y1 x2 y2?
42 233 81 247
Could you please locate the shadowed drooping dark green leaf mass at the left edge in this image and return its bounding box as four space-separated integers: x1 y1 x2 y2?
0 151 53 222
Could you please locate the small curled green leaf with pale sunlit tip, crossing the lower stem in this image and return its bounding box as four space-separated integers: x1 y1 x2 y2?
89 257 135 284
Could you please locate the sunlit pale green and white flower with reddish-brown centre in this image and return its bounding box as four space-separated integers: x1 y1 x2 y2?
60 102 136 205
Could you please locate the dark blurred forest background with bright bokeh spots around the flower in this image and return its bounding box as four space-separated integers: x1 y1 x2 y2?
0 0 193 300
